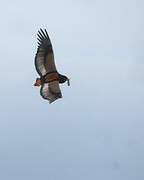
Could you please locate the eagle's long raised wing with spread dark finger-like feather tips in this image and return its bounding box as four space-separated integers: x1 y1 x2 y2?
35 29 56 76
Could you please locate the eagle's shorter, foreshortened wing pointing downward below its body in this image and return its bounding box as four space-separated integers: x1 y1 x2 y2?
40 81 62 103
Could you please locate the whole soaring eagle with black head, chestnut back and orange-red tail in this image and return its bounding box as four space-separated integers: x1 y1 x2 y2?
34 29 70 103
